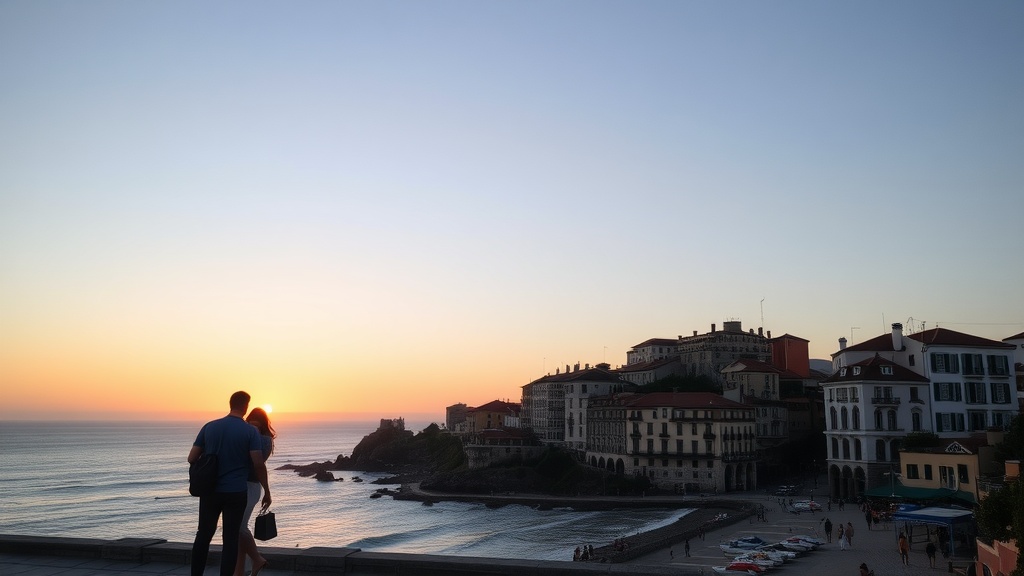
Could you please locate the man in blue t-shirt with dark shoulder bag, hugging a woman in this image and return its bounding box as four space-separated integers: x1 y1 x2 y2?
188 392 271 576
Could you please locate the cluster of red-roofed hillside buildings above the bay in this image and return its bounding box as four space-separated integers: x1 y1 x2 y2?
445 320 1024 573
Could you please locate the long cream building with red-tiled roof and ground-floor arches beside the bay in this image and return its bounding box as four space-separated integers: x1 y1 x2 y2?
587 393 757 492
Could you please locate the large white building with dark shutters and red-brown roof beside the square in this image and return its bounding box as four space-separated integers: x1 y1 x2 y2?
822 324 1017 498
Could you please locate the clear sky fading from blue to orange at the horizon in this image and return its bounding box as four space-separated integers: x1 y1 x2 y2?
0 0 1024 421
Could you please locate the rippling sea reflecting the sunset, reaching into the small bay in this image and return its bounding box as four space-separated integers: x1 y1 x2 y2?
0 422 688 560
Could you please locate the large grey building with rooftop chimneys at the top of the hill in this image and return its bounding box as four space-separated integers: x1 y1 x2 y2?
678 320 771 383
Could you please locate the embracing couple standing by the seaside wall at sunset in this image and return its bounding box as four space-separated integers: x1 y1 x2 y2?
188 392 278 576
